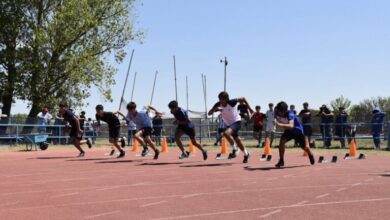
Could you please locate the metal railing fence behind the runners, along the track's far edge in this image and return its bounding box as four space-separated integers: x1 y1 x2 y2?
0 118 390 150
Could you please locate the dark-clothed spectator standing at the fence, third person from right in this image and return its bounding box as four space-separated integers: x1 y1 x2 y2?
317 105 333 149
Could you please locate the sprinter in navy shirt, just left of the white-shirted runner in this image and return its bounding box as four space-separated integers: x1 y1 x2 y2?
168 101 207 160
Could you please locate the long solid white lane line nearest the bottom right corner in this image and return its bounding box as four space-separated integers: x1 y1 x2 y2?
152 197 390 220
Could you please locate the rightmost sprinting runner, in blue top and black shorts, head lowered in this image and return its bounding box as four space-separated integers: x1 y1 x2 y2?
275 102 315 168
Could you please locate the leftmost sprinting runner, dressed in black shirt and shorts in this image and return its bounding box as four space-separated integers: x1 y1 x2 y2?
59 104 92 157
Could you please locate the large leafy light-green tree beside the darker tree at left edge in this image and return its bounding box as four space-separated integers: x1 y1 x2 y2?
0 0 143 120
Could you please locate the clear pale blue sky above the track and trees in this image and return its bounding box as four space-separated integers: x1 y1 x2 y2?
13 0 390 115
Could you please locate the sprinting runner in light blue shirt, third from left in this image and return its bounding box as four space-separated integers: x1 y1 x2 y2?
114 102 162 160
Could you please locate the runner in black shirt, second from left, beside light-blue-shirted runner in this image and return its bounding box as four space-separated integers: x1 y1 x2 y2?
94 105 126 158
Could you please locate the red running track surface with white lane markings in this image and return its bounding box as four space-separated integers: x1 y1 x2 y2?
0 148 390 220
